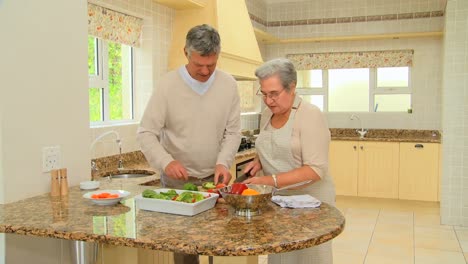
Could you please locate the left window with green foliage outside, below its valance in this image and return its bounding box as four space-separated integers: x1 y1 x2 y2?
88 36 134 125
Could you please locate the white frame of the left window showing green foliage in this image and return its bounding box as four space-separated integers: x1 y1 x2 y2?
88 37 136 127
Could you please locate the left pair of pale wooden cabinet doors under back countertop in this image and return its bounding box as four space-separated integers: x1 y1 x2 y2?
329 141 399 198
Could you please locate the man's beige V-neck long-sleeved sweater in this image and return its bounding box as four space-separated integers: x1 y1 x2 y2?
137 70 240 178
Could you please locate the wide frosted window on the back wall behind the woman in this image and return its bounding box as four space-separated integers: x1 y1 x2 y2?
296 67 412 112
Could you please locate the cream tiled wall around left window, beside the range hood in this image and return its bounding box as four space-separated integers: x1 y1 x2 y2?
89 0 175 158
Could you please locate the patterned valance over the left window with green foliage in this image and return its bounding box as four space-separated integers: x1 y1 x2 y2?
88 3 143 47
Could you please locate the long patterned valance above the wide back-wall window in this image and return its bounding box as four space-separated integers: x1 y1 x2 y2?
286 50 413 70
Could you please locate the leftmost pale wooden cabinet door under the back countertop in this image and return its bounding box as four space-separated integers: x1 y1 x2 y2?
329 141 358 196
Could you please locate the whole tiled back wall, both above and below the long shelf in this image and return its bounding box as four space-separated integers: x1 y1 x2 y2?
258 0 445 130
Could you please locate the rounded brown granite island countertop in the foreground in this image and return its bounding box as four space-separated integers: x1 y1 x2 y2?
0 175 345 256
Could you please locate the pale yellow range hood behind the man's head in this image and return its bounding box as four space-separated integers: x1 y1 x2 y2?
169 0 263 80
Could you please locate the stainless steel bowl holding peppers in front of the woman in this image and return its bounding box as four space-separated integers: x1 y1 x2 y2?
219 184 275 217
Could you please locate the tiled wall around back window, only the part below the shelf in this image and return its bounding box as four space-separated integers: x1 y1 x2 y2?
266 38 442 130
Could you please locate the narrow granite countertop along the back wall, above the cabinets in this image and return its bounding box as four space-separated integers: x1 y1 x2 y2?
330 128 441 143
